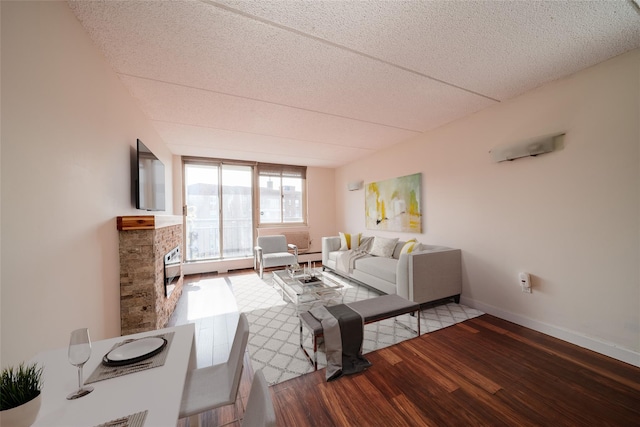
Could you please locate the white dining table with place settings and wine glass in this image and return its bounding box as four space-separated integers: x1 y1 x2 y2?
32 324 196 427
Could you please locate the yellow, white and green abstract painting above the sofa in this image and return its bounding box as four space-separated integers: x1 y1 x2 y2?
364 173 422 233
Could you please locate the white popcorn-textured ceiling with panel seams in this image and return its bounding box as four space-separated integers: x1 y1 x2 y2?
69 0 640 167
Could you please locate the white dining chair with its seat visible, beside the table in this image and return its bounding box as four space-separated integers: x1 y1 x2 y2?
179 313 249 427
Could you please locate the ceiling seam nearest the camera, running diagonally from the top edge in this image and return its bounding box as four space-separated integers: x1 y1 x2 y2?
199 0 500 102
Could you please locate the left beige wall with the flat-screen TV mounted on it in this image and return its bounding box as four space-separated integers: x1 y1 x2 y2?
1 1 173 366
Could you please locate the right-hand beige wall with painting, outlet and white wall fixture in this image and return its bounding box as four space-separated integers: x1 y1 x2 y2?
336 50 640 366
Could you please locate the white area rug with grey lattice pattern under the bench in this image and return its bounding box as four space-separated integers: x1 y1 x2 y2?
228 273 483 385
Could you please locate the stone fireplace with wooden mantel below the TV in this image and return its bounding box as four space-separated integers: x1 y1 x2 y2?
117 215 184 335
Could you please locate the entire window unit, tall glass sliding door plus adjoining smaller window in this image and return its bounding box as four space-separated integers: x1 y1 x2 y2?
183 158 307 262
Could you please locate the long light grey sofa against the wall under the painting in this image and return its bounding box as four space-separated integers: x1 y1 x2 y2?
322 236 462 304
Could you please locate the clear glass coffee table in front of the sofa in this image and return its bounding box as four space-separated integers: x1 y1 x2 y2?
273 269 344 309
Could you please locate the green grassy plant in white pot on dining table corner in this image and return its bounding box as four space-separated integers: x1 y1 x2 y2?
0 363 42 427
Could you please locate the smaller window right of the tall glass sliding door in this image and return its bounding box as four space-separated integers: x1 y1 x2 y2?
258 164 307 225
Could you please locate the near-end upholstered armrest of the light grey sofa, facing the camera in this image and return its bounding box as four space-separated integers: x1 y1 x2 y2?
396 247 462 304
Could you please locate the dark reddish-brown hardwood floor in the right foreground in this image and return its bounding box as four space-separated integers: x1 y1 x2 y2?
178 272 640 427
